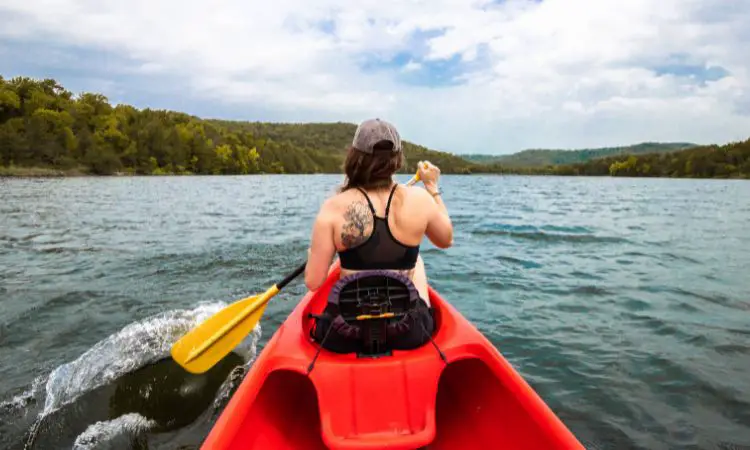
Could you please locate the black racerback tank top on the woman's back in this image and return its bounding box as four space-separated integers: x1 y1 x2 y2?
339 185 419 270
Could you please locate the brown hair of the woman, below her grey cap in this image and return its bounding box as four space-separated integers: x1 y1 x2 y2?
339 141 404 192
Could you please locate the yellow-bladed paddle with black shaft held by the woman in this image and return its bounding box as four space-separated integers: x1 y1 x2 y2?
171 168 426 373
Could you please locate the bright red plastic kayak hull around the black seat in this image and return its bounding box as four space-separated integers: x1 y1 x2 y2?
202 268 584 450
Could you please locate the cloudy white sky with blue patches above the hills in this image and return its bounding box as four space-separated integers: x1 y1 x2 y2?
0 0 750 154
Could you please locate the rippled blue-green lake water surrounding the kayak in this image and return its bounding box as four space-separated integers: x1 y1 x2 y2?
0 175 750 449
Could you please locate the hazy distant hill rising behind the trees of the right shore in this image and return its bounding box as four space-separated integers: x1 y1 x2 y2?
461 142 696 168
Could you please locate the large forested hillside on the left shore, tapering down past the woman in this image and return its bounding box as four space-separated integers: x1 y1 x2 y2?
0 77 475 174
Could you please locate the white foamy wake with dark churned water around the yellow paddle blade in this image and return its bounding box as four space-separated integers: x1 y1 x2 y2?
0 303 260 450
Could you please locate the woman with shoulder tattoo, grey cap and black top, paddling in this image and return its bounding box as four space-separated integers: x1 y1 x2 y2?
305 119 453 350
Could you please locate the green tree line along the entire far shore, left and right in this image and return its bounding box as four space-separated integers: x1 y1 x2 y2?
0 76 750 178
